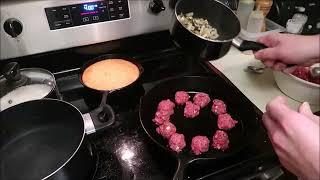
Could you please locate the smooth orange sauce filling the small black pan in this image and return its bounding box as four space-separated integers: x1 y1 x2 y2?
82 59 140 91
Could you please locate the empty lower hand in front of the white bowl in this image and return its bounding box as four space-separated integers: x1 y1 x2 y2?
262 97 320 179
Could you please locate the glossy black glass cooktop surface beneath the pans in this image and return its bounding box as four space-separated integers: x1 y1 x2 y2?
1 32 278 180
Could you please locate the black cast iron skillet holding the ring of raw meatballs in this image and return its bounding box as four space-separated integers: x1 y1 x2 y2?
139 76 258 180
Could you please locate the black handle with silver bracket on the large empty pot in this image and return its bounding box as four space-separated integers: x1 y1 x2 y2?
83 92 115 134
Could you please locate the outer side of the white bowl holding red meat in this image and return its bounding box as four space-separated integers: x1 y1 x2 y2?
273 71 320 105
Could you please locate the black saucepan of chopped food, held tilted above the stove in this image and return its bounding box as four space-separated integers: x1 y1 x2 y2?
170 0 266 60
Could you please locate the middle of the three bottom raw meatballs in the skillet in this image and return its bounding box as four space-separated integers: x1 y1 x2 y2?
191 136 210 155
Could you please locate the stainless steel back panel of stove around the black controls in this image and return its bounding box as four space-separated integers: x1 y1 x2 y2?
0 0 173 61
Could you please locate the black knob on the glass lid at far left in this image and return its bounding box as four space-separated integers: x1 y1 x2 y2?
2 62 21 82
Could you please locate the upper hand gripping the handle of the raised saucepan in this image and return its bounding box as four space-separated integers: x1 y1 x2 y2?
254 33 320 70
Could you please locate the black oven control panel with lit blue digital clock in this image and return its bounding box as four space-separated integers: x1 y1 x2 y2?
45 0 130 30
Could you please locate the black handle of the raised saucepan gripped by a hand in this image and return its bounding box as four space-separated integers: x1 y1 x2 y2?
232 38 268 51
